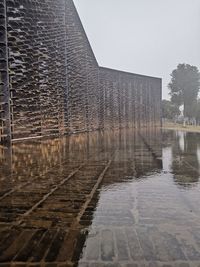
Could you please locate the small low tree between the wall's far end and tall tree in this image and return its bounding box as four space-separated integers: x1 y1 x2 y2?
162 100 180 120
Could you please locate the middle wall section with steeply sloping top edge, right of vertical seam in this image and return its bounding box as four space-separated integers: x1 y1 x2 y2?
66 0 99 132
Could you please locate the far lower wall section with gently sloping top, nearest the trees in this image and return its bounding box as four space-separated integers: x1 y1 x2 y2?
99 67 162 129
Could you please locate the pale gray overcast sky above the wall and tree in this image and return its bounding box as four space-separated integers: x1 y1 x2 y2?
74 0 200 98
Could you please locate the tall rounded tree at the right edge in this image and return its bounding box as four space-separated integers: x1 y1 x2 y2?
168 64 200 118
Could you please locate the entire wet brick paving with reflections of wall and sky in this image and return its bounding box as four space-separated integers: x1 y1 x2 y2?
0 129 200 267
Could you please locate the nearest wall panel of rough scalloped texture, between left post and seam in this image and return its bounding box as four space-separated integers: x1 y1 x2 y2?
6 0 66 139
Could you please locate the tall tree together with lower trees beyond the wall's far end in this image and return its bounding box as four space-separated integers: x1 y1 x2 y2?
162 64 200 123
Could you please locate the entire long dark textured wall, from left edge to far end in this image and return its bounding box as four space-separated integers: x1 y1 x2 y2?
0 0 161 142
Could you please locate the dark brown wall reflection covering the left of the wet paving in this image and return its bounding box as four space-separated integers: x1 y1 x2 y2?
0 129 162 262
